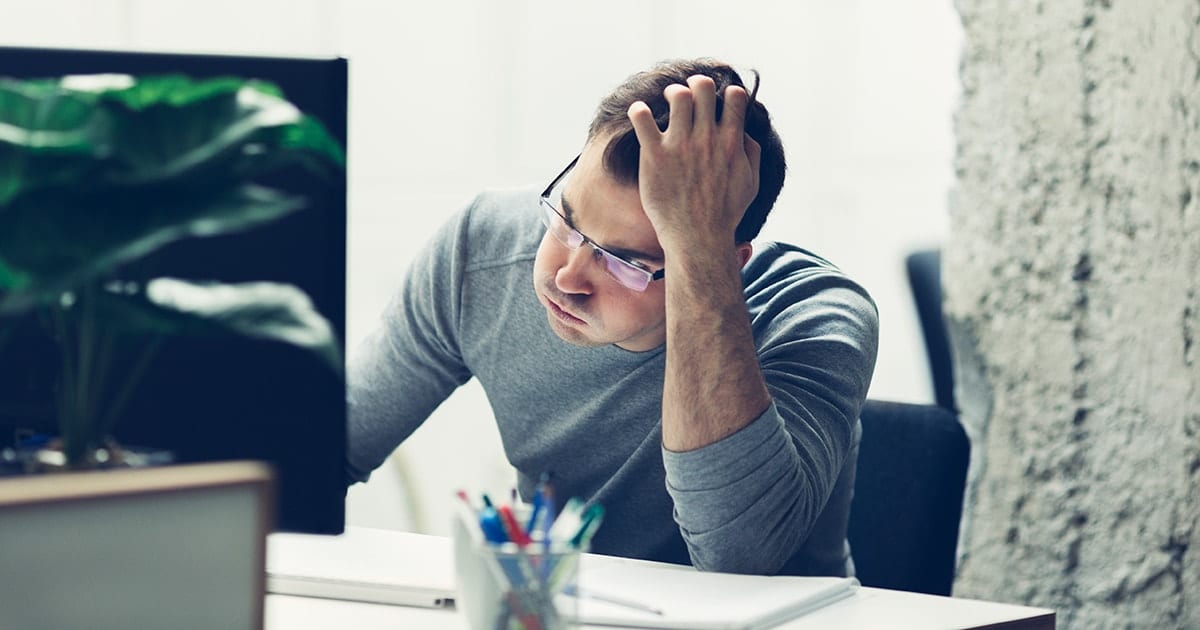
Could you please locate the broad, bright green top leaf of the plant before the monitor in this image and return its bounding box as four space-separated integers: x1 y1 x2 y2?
0 76 346 204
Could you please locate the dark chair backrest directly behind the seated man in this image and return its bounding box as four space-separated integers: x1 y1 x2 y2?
847 401 971 595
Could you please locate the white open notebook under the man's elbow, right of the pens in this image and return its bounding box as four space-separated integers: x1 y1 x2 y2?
564 564 858 630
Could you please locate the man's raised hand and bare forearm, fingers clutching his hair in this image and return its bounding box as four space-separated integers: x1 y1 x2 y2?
629 77 770 451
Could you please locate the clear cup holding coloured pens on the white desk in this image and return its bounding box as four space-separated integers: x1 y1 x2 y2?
454 522 580 630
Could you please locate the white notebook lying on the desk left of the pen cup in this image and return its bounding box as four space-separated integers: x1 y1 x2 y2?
266 527 455 608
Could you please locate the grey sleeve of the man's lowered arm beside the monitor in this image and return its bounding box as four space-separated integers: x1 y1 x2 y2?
346 199 478 484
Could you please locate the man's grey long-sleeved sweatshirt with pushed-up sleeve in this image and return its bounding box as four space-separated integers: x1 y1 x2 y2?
347 191 878 575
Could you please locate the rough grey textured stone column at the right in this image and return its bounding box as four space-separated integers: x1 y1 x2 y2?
943 0 1200 628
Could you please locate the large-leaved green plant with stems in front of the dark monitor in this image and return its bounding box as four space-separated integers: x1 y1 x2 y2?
0 74 344 468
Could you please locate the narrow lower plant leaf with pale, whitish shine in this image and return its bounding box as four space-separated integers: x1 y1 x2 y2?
100 277 342 373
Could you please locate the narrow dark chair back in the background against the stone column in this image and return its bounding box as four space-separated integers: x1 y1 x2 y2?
905 248 958 412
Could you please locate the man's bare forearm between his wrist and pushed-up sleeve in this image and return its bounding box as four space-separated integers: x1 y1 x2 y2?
662 244 770 451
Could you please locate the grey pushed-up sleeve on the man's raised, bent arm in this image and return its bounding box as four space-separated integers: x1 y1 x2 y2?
662 262 878 575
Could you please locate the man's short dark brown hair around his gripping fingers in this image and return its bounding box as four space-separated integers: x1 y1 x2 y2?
588 59 787 242
